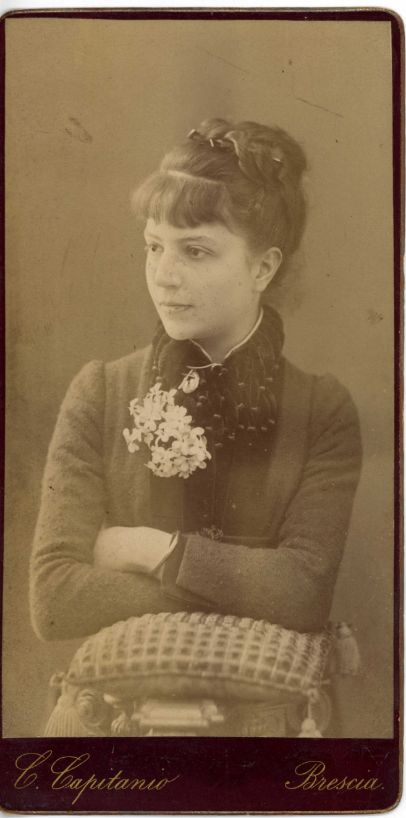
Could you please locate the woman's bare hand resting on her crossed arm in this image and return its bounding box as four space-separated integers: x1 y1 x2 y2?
94 526 173 578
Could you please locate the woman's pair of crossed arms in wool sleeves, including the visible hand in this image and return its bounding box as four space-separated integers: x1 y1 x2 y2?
31 358 361 639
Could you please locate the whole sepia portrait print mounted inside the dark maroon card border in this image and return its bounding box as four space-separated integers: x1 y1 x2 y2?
2 6 400 772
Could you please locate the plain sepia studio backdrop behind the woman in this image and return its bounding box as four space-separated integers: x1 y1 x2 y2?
3 19 393 737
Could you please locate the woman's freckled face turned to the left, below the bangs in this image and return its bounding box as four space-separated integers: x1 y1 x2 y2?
145 219 270 361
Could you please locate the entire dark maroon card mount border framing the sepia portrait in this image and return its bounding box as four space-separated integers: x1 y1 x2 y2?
0 8 404 814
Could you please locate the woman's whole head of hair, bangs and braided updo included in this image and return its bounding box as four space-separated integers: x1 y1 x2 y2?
135 119 307 276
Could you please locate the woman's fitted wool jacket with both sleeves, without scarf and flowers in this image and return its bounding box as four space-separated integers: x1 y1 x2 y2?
30 348 361 639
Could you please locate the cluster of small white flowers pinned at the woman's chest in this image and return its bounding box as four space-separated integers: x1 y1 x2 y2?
123 383 211 479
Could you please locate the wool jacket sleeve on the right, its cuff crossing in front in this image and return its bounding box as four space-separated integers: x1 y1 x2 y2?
163 375 361 631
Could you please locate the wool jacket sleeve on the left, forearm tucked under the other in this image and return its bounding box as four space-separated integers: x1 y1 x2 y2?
30 361 185 639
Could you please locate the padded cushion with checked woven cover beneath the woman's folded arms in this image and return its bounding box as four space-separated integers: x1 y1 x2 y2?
66 613 330 701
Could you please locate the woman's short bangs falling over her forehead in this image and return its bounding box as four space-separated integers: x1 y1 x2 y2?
131 171 232 228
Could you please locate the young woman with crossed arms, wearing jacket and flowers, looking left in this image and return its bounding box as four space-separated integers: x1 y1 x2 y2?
31 120 361 639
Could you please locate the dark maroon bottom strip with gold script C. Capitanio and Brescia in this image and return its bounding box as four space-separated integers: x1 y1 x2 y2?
1 738 399 815
